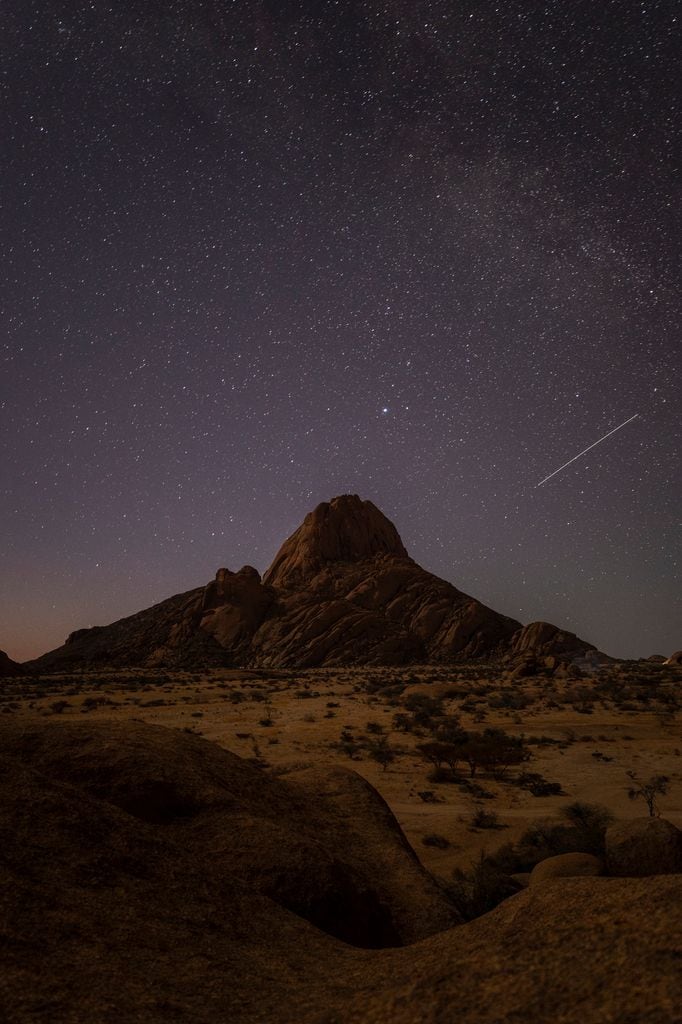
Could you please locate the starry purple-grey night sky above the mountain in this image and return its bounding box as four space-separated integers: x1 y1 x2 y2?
0 0 682 660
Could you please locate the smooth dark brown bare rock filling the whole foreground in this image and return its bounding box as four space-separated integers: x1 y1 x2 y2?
0 723 682 1024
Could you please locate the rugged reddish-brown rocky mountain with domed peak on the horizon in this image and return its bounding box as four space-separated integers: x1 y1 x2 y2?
23 495 592 672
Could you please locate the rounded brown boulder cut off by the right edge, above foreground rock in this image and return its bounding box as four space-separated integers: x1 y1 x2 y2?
606 818 682 878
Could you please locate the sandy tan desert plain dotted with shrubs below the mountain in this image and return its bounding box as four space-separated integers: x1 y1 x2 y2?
0 663 682 878
